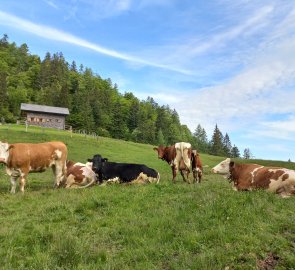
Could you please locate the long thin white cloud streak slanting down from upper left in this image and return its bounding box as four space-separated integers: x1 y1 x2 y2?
0 11 190 74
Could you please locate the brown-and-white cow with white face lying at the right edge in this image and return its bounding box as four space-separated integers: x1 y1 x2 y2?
212 158 295 197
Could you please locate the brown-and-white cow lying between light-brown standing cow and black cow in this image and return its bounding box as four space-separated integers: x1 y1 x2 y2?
63 160 97 188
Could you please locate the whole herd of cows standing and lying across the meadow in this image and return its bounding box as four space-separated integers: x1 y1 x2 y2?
0 141 295 197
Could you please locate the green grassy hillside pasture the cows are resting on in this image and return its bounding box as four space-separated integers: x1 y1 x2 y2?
0 125 295 269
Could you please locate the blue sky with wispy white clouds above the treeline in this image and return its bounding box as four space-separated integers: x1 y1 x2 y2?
0 0 295 161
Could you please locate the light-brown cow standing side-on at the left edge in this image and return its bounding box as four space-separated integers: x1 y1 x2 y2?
0 141 67 193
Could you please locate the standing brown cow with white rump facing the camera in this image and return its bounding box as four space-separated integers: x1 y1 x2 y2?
153 142 192 183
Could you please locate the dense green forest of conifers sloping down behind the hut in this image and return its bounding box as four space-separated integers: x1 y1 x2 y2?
0 34 250 158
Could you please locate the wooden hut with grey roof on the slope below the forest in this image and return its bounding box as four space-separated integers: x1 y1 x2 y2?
21 103 70 129
